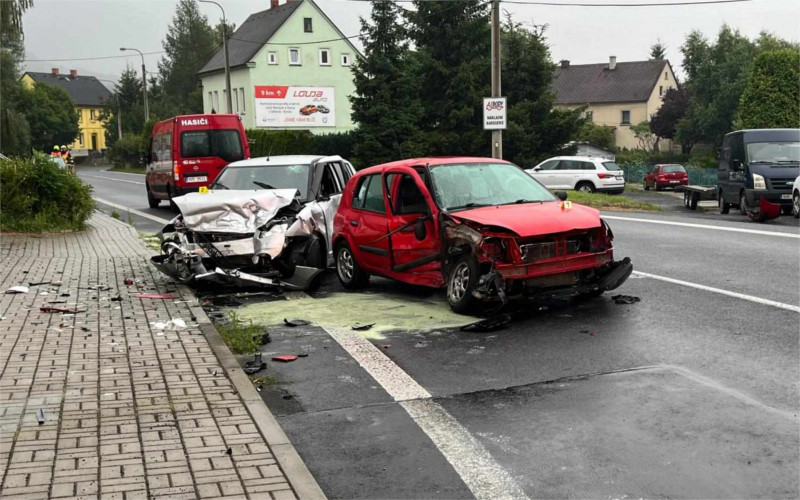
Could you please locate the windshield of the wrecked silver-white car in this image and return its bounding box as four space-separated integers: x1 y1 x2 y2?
211 165 311 200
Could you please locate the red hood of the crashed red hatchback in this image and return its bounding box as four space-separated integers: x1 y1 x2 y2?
450 202 600 238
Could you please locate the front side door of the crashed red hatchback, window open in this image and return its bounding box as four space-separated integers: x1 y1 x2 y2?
383 167 442 286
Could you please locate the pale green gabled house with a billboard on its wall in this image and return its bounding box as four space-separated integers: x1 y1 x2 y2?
198 0 359 134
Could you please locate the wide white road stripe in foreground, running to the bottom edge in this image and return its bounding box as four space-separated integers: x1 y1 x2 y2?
324 327 527 500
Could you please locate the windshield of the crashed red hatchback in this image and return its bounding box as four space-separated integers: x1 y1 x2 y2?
431 163 555 211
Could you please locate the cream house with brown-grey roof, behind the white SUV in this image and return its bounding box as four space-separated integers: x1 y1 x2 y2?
553 56 678 150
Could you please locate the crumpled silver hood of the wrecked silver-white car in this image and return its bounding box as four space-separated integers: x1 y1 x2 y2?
173 189 297 233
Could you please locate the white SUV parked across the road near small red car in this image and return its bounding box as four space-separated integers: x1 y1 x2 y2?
525 156 625 194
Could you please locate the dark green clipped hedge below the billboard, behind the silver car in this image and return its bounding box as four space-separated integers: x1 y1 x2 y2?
245 129 356 166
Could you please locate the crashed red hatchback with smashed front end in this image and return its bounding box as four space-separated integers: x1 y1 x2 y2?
333 158 633 313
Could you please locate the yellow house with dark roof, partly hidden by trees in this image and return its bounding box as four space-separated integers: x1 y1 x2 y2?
22 68 112 152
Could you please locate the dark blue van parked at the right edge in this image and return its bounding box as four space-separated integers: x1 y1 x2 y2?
717 129 800 214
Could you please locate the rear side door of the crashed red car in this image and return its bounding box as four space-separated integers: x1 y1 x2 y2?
347 174 390 274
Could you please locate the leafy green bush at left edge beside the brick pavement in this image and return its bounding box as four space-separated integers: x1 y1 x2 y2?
0 153 94 233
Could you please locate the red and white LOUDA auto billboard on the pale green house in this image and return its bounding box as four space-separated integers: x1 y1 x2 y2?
255 85 336 128
